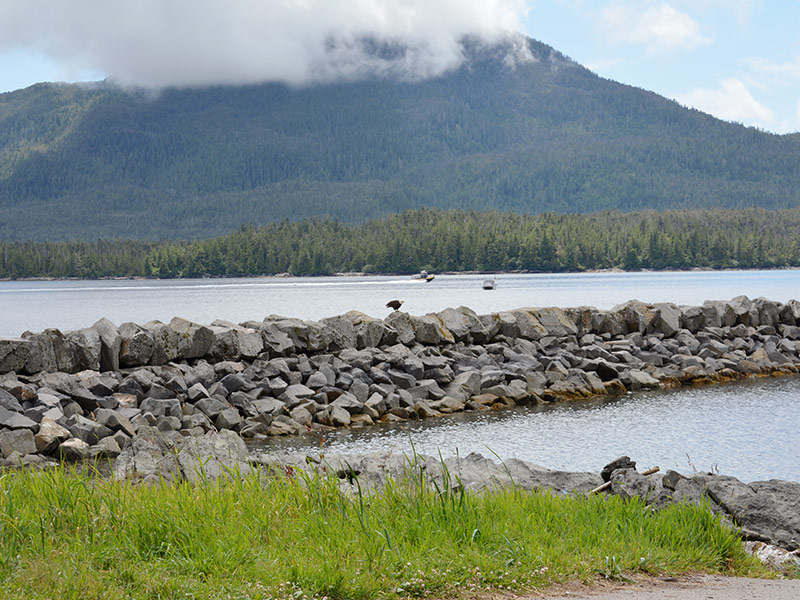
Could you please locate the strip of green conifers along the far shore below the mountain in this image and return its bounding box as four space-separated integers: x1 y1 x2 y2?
0 208 800 279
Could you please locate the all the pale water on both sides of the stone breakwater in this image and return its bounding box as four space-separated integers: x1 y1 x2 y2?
0 271 800 481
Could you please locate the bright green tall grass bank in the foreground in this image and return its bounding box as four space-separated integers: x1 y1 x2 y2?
0 460 764 600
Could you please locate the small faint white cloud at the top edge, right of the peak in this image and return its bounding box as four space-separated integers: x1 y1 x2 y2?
601 0 711 53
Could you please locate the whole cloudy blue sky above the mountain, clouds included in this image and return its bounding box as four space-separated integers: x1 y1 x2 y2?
0 0 800 133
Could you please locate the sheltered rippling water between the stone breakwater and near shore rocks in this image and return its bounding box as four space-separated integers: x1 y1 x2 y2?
256 377 800 481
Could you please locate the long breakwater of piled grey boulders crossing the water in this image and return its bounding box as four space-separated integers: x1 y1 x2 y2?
0 296 800 465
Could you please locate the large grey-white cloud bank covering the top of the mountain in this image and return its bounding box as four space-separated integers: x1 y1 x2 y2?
0 0 526 87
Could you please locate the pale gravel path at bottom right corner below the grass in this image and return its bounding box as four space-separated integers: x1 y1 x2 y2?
531 575 800 600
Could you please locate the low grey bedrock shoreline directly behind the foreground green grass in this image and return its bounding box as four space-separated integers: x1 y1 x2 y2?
113 427 800 570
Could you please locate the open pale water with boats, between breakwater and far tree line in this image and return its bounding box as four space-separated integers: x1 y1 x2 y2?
0 270 800 337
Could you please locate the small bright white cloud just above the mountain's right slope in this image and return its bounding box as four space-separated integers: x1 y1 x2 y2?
675 78 775 125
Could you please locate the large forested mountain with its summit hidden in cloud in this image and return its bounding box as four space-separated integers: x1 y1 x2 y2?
0 40 800 240
